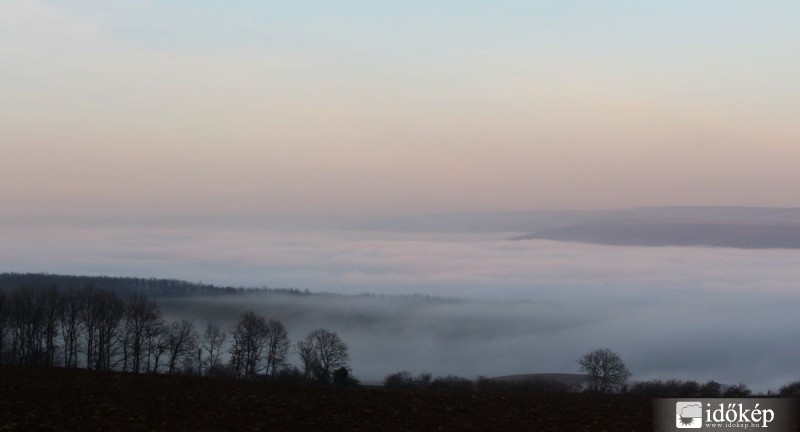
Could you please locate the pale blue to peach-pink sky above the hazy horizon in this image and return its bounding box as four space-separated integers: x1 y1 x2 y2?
0 0 800 217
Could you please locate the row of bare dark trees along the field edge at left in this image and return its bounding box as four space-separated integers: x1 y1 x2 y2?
0 285 353 384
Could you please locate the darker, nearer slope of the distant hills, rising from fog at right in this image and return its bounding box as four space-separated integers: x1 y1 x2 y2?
516 222 800 249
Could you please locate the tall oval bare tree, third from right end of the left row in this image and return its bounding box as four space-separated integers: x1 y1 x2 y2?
230 311 269 377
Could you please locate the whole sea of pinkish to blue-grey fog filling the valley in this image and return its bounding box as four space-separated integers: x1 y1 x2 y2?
0 225 800 390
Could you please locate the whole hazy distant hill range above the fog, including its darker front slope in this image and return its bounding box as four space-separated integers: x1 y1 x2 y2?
360 206 800 249
